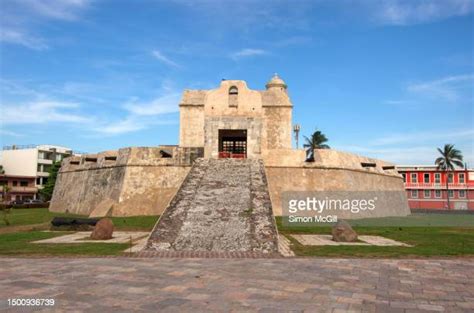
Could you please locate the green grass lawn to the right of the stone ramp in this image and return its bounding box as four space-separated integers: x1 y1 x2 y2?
277 214 474 257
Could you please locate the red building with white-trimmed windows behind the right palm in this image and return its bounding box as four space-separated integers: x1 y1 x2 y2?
397 165 474 210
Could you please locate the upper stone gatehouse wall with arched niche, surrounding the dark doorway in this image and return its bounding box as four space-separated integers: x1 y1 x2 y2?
180 80 292 158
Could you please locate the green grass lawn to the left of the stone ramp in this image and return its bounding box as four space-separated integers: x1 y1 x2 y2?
0 208 158 256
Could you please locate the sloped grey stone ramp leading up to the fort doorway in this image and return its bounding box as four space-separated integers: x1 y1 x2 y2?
145 159 278 253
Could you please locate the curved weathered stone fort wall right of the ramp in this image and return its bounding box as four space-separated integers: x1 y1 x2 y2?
264 149 410 218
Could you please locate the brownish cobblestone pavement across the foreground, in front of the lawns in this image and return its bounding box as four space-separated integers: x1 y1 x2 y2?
0 258 474 313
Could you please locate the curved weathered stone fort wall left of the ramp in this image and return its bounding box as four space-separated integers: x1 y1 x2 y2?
50 146 196 216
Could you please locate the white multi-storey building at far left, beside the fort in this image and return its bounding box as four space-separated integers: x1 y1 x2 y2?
0 145 73 189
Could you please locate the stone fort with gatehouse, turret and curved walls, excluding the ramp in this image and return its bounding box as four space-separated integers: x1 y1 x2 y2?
50 75 409 218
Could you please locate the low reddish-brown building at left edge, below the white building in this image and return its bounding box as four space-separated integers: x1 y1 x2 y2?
0 174 38 202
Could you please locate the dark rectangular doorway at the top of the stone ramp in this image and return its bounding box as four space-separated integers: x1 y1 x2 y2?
219 129 247 159
